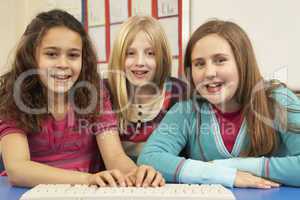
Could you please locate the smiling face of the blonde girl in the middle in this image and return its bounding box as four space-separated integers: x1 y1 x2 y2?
125 31 156 86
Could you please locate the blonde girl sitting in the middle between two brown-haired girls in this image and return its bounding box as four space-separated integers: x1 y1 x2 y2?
108 16 186 160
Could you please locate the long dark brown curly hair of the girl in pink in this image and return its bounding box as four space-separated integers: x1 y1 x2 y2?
0 9 100 132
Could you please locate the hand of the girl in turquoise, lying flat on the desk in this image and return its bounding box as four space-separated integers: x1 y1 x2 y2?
234 171 280 189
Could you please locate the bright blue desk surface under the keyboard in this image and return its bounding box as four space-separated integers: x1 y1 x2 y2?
0 177 300 200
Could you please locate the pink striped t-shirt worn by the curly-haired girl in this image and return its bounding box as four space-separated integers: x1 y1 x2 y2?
0 89 117 172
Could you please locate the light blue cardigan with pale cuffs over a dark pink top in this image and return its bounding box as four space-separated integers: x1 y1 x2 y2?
138 87 300 187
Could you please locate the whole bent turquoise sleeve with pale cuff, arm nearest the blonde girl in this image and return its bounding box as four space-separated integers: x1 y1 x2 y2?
137 103 236 187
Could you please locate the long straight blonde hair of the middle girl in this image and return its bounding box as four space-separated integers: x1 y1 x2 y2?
108 16 172 127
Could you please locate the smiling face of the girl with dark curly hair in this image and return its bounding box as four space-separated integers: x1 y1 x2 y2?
36 26 82 93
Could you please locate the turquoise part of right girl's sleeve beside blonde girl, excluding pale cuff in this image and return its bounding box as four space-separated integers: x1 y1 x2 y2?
137 101 192 182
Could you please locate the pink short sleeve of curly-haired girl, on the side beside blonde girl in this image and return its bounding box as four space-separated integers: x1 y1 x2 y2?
93 82 118 135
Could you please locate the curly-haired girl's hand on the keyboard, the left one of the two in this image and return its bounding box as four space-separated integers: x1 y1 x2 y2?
88 170 126 187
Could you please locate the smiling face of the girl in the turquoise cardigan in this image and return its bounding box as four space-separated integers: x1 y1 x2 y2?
191 34 239 112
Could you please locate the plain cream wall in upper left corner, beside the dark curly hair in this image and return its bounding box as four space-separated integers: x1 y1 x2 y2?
0 0 81 75
